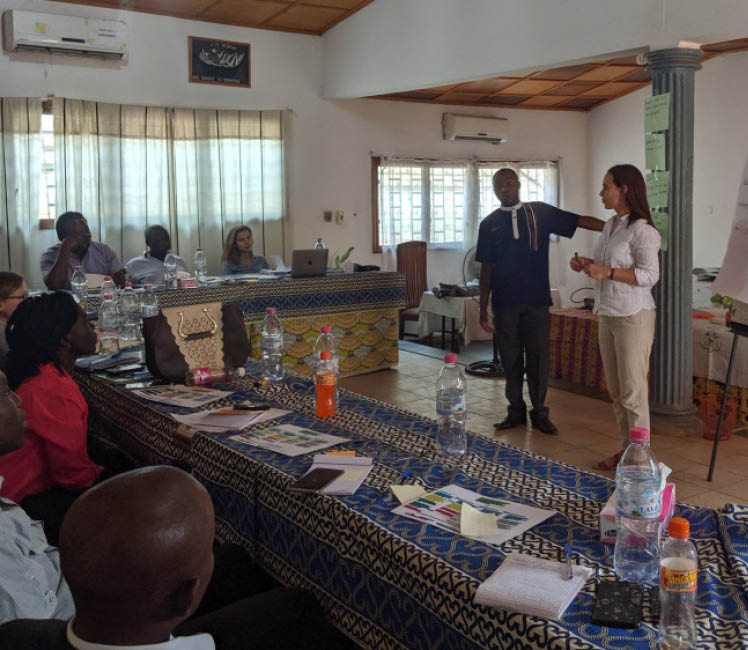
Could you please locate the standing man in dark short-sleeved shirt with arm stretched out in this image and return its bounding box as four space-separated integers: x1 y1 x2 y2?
475 168 604 434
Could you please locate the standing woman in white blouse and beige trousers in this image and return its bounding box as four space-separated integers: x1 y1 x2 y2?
570 165 660 470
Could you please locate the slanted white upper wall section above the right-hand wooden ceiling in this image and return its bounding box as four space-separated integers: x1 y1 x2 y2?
324 0 748 98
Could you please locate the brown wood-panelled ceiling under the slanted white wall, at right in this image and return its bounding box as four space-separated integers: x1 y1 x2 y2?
374 38 748 111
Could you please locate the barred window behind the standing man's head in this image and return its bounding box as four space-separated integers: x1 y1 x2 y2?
372 157 558 253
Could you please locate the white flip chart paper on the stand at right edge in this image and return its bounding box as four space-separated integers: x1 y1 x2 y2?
712 154 748 302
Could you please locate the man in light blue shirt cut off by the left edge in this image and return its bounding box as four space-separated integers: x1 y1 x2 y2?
0 372 74 620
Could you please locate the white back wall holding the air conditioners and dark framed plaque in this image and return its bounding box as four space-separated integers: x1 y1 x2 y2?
0 0 588 304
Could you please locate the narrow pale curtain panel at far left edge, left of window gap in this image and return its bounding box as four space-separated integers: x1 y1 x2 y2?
0 98 42 288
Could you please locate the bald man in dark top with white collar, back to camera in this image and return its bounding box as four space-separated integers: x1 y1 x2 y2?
0 467 353 650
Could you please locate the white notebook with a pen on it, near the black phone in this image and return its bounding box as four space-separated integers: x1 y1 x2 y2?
474 553 592 620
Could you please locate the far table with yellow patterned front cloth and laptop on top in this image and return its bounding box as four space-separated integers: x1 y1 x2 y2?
89 272 405 377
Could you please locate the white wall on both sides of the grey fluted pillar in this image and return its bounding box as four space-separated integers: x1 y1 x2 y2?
588 52 748 267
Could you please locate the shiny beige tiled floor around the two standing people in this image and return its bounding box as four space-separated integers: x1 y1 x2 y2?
341 350 748 508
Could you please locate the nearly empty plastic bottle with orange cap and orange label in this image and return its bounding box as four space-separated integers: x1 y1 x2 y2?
660 517 699 650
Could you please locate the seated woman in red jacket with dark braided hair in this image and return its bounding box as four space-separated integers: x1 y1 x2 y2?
0 292 102 544
